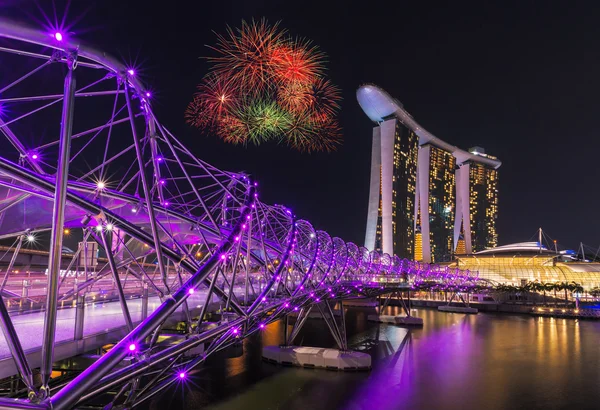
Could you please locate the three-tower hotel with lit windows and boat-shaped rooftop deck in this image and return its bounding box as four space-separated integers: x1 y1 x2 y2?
357 84 501 262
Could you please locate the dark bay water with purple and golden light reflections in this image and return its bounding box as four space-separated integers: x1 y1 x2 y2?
150 307 600 410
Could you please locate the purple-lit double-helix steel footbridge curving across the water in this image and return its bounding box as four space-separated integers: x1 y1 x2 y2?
0 19 477 409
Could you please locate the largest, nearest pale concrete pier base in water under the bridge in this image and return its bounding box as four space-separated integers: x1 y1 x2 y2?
263 346 371 371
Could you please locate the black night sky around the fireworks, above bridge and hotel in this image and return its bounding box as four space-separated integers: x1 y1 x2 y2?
0 0 600 248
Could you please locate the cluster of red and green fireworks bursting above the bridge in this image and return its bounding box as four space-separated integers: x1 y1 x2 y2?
185 20 341 152
